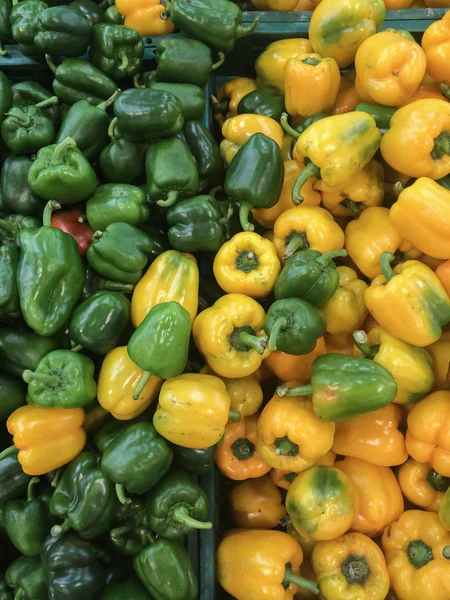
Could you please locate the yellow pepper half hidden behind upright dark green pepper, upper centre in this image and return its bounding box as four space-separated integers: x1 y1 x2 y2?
220 114 284 165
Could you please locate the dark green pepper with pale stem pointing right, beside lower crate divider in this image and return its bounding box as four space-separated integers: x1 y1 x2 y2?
145 467 212 540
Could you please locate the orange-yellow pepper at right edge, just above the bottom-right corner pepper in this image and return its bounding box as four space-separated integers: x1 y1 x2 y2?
397 458 450 512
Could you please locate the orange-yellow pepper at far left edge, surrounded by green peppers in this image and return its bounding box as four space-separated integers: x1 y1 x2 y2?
6 404 86 476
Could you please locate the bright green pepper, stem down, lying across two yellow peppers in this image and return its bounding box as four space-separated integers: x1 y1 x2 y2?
127 302 192 400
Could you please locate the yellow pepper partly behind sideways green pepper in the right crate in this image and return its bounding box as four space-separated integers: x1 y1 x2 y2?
353 327 434 406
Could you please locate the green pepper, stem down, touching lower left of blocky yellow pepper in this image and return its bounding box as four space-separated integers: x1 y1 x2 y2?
101 423 173 503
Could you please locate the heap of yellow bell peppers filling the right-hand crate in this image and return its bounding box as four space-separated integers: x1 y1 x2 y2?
212 0 450 600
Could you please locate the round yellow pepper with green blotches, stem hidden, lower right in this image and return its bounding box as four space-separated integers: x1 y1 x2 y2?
286 465 358 541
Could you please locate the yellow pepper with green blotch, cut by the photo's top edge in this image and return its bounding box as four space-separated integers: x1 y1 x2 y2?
309 0 386 68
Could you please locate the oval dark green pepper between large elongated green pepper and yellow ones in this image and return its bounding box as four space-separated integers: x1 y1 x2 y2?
69 290 131 354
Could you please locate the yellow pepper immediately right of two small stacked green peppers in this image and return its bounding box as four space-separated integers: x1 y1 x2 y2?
320 267 368 338
